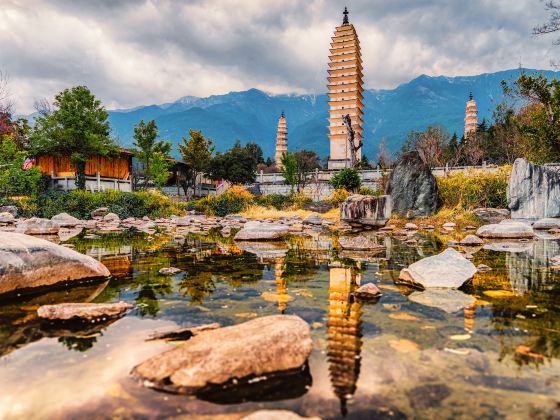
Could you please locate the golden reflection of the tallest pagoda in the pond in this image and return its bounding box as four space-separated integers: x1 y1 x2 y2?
327 267 362 415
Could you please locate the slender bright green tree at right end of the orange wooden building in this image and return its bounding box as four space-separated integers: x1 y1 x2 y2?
133 120 171 187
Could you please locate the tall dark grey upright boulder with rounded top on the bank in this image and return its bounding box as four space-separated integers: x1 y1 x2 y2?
386 151 440 217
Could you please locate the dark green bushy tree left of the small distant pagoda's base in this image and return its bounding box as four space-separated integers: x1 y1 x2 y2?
209 140 257 184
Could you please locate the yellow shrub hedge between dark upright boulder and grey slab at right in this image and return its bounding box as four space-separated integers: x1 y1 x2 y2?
437 167 511 209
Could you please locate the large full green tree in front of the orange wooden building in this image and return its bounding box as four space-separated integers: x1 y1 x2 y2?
30 86 117 189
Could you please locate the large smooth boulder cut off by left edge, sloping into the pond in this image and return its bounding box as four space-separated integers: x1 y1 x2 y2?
0 232 110 294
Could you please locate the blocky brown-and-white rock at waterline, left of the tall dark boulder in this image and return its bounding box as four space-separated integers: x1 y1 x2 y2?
340 194 392 226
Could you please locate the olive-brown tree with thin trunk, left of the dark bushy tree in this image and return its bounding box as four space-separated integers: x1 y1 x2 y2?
179 130 214 195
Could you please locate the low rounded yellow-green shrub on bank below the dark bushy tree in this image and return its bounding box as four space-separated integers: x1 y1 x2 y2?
190 185 254 216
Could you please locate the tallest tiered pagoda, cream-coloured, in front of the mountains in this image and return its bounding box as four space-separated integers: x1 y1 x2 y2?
327 8 364 169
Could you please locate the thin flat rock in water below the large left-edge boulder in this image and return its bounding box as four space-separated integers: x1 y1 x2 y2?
37 302 134 321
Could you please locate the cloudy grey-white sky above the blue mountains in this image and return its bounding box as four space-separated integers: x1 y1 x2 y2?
0 0 560 113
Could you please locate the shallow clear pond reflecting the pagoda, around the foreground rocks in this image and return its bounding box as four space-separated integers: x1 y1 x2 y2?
0 232 560 419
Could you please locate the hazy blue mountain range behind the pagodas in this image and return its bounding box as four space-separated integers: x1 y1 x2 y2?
109 69 560 158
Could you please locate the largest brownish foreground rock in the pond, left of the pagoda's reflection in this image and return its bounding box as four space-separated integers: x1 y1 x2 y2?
132 315 313 394
